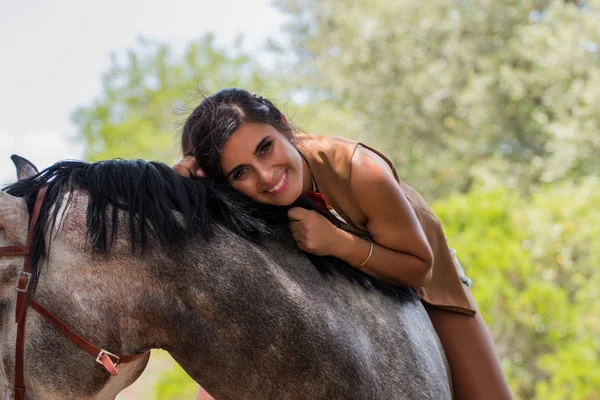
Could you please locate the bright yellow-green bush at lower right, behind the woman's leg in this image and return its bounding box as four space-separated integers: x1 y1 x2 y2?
433 178 600 400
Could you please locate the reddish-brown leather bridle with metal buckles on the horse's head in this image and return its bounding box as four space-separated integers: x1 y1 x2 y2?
0 186 147 400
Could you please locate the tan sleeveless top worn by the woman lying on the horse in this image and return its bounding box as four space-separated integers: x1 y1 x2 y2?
296 135 475 316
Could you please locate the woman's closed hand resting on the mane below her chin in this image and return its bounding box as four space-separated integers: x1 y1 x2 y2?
288 207 339 256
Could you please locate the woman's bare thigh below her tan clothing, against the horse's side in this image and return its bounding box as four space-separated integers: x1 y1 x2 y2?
425 290 512 400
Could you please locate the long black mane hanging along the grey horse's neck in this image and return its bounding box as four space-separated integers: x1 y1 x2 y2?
4 159 416 301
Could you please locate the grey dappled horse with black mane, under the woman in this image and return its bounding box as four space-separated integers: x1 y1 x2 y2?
0 158 451 400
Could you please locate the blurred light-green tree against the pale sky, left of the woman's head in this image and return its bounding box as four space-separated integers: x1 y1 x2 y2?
72 34 286 162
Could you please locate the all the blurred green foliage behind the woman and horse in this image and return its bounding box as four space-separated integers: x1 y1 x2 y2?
73 0 600 400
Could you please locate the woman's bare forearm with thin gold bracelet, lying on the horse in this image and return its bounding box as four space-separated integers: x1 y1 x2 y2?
330 229 433 288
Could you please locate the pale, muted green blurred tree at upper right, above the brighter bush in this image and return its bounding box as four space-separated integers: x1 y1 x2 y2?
276 0 600 197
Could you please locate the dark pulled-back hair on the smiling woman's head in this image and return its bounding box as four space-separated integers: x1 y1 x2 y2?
181 88 294 180
